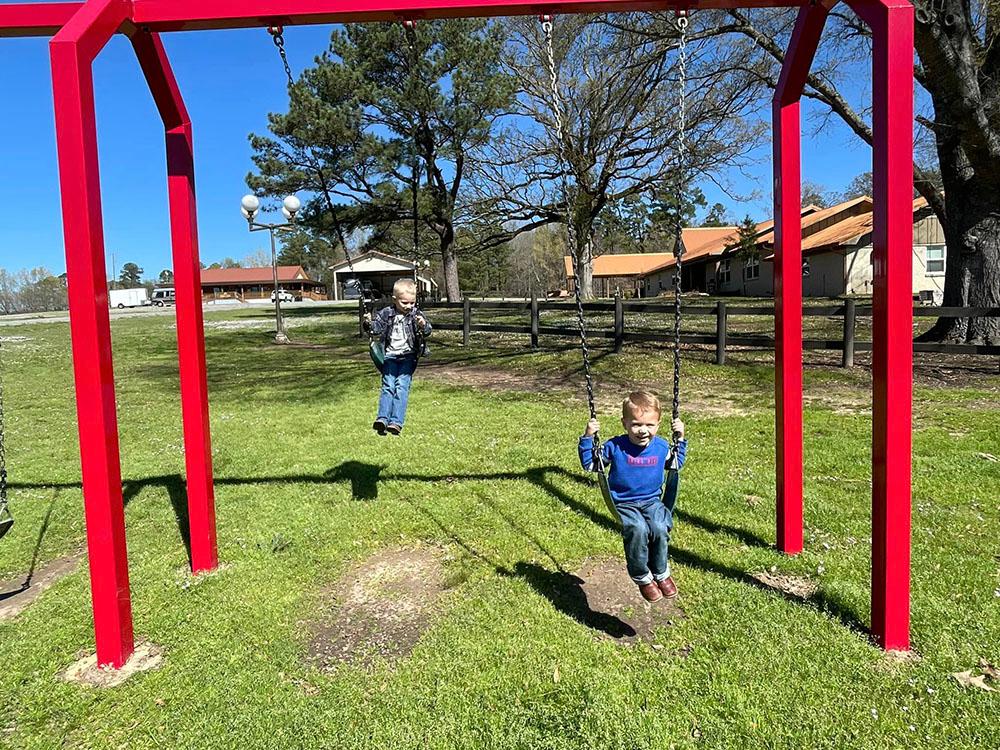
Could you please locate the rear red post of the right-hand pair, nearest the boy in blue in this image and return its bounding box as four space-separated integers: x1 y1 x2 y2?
772 4 829 555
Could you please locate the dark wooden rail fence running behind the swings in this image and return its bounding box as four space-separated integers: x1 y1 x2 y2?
364 297 1000 367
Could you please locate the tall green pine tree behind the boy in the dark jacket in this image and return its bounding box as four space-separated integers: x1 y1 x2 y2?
249 19 514 299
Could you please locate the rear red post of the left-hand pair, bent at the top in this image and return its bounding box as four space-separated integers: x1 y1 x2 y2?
132 31 219 573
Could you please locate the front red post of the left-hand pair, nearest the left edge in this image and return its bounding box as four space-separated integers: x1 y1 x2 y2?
49 0 134 667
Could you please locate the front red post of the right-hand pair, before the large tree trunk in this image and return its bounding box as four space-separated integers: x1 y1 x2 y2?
852 0 913 650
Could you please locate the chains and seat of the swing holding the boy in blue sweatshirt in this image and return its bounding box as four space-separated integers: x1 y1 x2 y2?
541 16 688 523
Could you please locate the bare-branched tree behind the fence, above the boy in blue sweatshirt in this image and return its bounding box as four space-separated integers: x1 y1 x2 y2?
480 14 762 297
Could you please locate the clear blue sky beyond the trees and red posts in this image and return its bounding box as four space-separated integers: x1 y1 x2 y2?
0 19 871 277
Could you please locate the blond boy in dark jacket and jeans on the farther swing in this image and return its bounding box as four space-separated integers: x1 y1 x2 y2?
365 279 431 435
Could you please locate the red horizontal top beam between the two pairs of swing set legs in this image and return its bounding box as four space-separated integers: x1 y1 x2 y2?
133 0 803 31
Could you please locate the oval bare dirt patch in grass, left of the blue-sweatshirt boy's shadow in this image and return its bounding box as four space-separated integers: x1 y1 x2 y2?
308 546 445 669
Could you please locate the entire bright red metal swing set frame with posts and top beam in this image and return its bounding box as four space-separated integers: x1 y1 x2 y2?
0 0 913 667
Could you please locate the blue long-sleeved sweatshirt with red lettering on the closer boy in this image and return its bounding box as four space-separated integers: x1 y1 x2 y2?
580 435 687 505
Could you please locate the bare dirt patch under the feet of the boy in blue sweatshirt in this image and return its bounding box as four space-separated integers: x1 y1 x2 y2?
567 559 684 645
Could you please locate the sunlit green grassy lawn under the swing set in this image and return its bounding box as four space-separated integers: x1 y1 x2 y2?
0 310 1000 750
